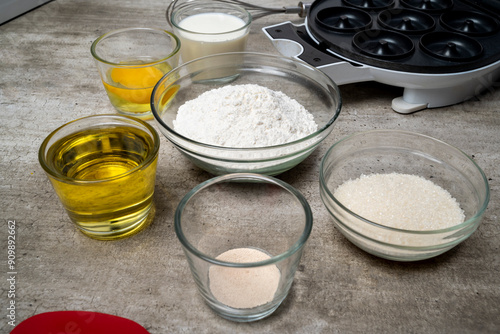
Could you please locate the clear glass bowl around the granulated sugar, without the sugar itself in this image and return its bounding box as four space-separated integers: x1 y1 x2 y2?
320 130 490 261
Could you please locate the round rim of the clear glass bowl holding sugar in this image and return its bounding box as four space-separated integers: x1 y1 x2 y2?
319 129 490 234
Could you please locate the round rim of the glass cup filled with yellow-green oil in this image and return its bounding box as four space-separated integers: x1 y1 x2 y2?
38 114 160 184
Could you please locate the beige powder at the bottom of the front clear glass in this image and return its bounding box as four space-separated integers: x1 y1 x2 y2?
208 248 281 308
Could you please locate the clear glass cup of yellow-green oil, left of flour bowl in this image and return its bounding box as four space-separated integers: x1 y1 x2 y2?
39 115 160 240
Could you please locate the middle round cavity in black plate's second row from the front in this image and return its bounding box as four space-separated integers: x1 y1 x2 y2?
378 9 436 34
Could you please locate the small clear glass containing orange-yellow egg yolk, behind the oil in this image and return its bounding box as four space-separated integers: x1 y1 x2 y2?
90 28 180 119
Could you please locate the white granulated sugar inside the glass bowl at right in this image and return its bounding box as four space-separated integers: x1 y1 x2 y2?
334 173 465 231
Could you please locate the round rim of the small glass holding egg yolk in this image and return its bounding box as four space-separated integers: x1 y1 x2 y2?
90 27 181 68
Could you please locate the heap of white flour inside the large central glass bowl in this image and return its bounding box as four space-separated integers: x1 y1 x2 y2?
174 84 318 148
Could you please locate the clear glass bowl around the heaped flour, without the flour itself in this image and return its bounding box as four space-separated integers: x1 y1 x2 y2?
151 52 342 175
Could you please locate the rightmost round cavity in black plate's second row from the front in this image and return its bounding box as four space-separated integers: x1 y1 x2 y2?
439 11 500 36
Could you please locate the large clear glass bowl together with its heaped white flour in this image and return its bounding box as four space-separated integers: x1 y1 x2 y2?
151 52 342 175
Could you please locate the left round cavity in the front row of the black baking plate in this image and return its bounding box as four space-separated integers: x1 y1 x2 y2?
352 29 415 59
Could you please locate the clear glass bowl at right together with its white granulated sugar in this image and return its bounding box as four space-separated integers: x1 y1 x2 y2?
320 130 490 261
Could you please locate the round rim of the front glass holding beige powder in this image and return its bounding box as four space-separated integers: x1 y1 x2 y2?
174 173 313 268
